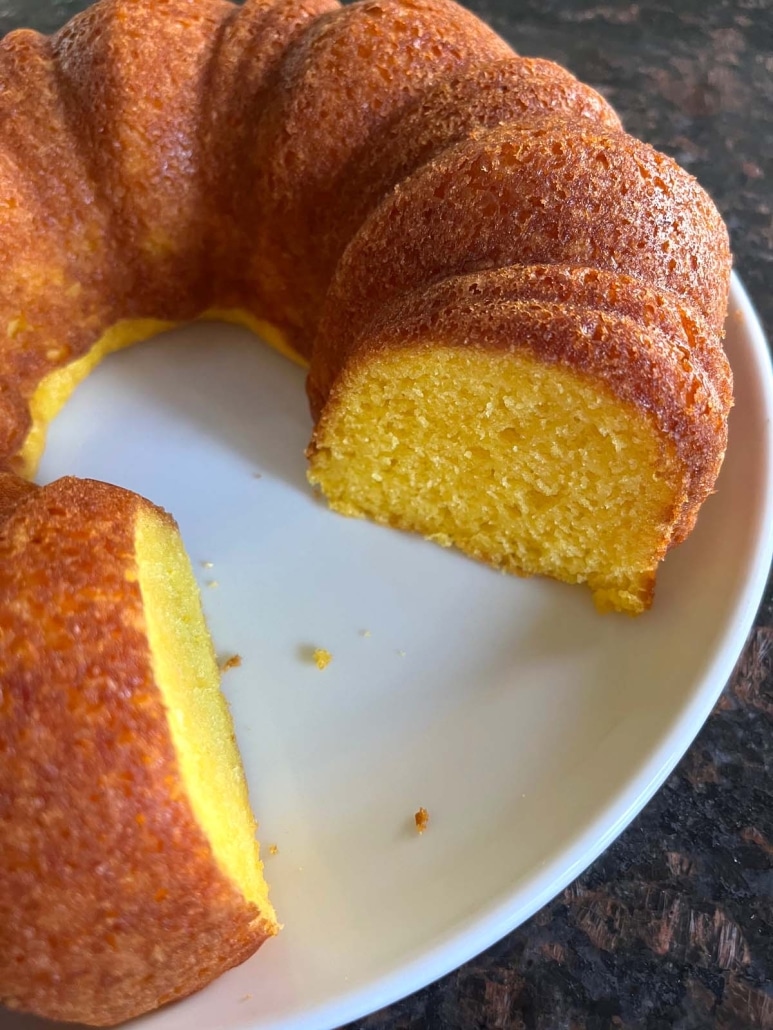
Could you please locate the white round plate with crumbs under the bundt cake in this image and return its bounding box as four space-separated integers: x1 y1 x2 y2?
0 280 773 1030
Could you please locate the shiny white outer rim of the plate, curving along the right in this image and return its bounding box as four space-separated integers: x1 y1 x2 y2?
239 271 773 1030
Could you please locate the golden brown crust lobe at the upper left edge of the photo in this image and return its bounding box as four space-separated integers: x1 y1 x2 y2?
0 30 116 458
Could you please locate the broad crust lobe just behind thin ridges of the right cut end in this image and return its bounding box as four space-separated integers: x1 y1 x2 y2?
310 118 731 397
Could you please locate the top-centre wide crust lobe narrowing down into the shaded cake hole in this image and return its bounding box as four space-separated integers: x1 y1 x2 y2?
245 0 512 356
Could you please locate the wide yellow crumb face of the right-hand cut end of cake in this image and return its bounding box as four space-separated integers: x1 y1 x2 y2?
309 346 682 613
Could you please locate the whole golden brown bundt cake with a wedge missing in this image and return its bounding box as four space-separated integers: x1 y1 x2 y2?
0 0 732 1024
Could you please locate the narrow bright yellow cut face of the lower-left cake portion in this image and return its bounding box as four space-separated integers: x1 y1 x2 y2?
135 510 278 932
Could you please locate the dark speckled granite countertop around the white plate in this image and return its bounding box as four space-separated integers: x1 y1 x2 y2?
0 0 773 1030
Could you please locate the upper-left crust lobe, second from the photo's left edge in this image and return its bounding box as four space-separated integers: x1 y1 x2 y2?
52 0 233 319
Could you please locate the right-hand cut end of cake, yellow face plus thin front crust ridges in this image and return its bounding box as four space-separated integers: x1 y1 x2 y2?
308 269 729 614
